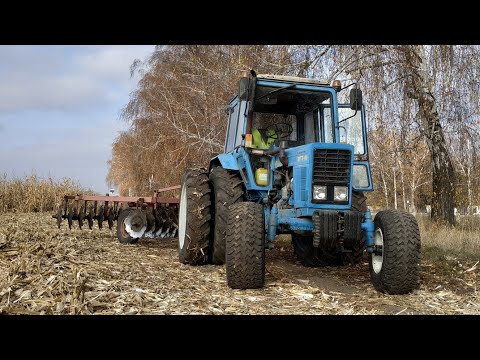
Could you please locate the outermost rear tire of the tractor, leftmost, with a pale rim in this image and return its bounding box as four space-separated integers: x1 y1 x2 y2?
178 168 211 265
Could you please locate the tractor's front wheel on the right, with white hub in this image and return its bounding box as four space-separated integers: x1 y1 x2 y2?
369 210 421 295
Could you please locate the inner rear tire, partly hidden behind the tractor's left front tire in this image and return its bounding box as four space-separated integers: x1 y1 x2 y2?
210 167 244 265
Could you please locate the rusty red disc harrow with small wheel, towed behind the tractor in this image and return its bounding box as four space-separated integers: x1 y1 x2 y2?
52 186 180 242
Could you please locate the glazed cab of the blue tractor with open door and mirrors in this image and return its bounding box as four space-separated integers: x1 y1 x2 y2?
223 73 373 195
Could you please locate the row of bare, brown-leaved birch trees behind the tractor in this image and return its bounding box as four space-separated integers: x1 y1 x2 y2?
107 45 480 224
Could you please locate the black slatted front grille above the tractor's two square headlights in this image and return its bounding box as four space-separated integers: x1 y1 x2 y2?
312 149 352 186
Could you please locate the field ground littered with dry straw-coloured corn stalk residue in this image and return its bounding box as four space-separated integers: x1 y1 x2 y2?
0 213 480 314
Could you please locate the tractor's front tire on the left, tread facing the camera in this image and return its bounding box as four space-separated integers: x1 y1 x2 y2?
225 202 265 289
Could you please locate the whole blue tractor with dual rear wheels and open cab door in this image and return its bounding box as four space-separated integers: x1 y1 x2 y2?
178 70 420 294
